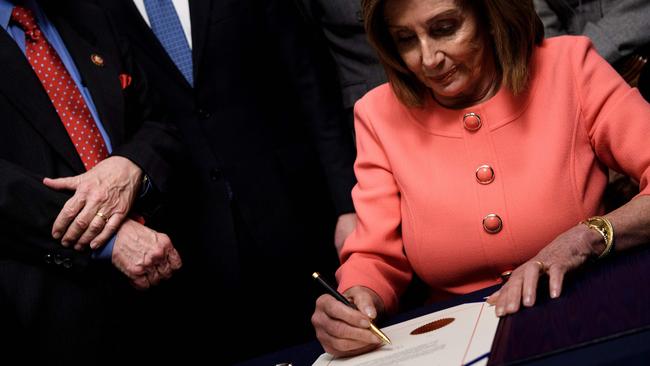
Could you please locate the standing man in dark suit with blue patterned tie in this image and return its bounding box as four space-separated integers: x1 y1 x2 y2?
98 0 355 364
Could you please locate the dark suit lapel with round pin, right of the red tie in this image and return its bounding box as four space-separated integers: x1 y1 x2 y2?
50 5 124 146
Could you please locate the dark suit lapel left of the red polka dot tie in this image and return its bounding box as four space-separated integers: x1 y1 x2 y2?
0 31 85 172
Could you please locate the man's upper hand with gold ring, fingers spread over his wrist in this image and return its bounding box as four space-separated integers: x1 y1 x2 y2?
43 156 143 250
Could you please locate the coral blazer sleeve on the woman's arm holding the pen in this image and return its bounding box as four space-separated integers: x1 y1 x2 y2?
336 98 413 312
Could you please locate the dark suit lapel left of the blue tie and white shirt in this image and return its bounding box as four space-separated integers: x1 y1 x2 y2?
114 0 191 88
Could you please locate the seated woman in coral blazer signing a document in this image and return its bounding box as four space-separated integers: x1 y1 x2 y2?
312 0 650 356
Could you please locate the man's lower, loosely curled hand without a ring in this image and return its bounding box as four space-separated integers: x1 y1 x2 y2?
112 219 182 290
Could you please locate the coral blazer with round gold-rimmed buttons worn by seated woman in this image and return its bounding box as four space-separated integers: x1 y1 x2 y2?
337 36 650 311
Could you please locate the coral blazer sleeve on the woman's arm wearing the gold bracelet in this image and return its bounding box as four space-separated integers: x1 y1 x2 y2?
570 38 650 195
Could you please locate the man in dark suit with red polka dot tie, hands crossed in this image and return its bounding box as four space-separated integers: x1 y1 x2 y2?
0 0 180 364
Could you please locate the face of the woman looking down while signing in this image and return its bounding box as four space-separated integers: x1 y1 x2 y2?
384 0 496 107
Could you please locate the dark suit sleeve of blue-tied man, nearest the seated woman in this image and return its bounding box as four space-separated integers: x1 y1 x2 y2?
266 0 355 214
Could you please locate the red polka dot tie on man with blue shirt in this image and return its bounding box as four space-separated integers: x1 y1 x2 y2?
11 6 108 170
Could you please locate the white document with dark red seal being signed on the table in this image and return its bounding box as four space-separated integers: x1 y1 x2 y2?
313 302 499 366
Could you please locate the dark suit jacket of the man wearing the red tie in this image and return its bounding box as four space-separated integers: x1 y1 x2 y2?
0 1 178 363
